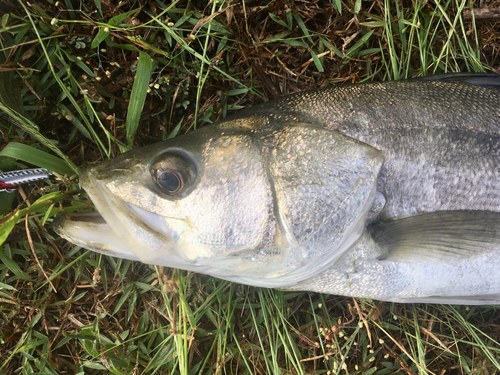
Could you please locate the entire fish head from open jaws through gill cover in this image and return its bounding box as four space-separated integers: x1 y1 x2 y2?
56 119 383 287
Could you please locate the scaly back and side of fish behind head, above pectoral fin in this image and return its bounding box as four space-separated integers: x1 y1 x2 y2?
231 80 500 219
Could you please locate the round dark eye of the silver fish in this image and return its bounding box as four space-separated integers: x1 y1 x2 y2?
151 152 195 196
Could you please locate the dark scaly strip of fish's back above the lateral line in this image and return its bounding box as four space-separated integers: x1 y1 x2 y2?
250 78 500 135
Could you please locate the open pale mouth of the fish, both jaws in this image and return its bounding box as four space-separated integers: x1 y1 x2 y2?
54 169 178 263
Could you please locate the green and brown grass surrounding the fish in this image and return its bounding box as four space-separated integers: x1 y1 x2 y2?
0 0 500 375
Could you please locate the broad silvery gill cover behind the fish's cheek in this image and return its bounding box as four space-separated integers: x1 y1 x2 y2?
248 123 384 287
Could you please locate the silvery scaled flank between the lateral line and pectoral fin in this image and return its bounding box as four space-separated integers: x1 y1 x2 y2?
355 129 500 219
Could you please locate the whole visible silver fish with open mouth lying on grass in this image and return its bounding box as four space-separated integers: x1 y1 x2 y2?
54 73 500 305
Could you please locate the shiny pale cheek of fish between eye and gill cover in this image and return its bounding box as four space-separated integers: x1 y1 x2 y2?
170 135 275 264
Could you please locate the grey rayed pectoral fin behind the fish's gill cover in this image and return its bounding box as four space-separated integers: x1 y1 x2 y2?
368 211 500 263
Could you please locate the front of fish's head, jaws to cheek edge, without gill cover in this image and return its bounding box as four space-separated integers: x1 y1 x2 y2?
56 126 280 278
